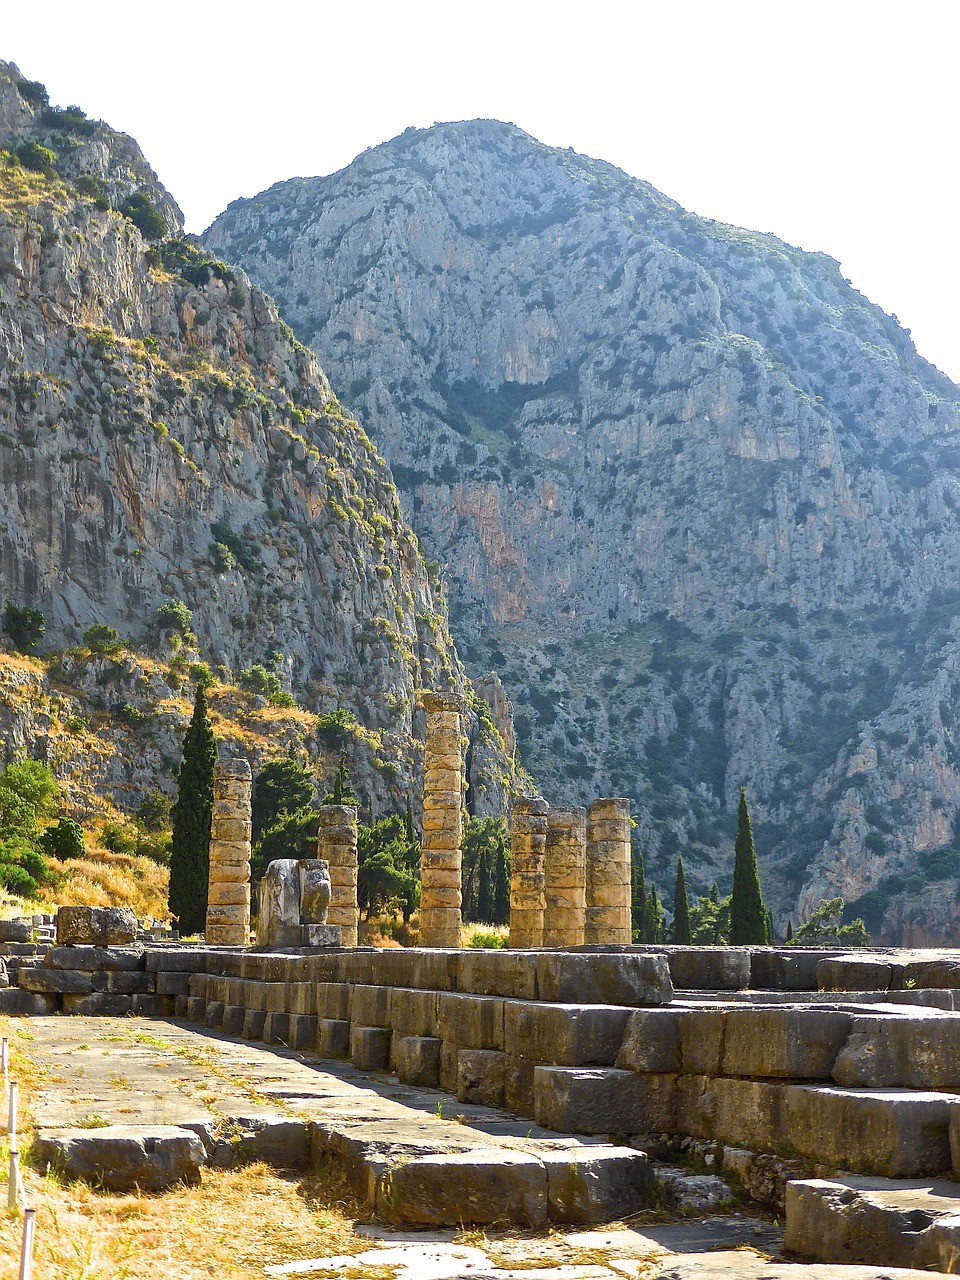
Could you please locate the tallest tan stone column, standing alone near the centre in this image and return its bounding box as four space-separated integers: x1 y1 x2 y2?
417 690 467 947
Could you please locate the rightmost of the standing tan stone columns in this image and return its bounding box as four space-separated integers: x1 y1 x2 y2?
584 797 631 946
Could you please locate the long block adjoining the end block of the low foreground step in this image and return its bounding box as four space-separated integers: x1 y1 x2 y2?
376 1148 547 1226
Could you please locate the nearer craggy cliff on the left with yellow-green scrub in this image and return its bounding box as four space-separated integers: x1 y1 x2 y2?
0 64 519 813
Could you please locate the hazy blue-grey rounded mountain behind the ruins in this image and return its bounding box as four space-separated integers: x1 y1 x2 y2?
205 120 960 942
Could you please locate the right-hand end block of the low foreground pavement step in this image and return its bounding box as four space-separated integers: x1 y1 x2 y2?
539 1146 655 1224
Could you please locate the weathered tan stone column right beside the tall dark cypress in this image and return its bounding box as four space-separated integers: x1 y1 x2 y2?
204 760 252 947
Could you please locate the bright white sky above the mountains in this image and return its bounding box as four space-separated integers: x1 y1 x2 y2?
7 0 960 380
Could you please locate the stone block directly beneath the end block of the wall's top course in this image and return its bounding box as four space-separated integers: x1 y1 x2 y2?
503 1000 630 1066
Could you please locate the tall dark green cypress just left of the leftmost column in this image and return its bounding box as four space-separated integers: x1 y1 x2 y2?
168 684 216 934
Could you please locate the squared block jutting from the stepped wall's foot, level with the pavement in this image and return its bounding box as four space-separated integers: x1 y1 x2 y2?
534 1066 677 1134
